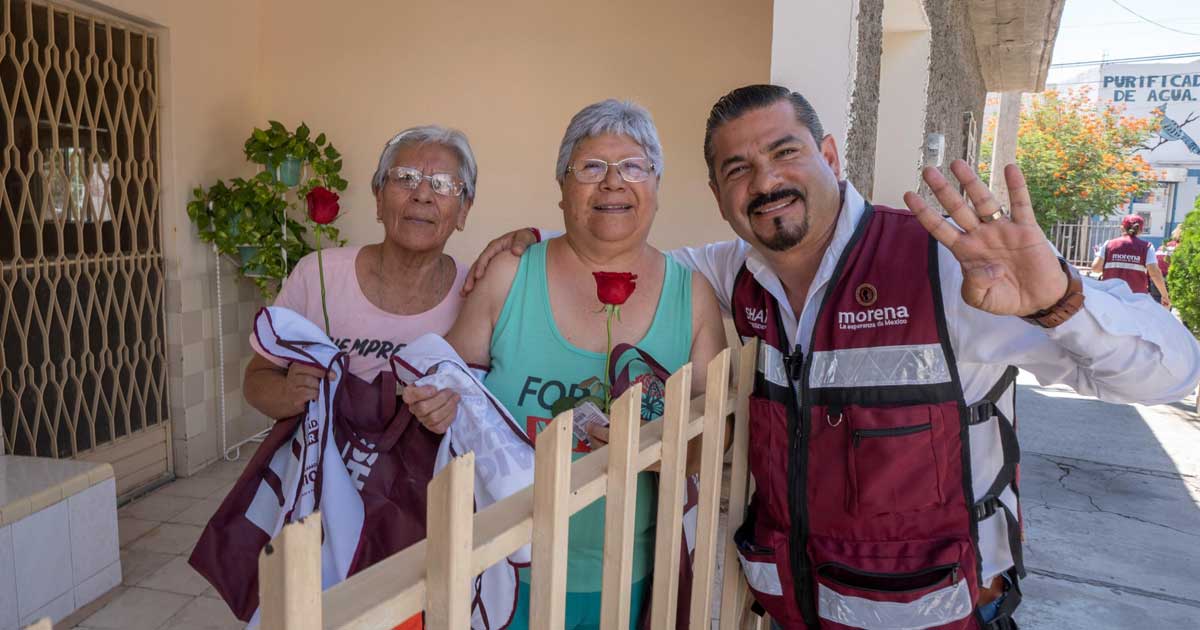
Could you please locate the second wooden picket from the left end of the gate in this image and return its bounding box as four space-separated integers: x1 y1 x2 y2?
424 452 475 630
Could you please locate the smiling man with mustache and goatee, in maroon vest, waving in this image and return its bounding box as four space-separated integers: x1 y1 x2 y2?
464 85 1200 630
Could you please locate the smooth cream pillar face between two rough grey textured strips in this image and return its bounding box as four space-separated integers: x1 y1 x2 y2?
871 28 929 205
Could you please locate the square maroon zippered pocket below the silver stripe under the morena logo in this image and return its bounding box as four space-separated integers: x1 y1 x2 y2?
846 406 944 516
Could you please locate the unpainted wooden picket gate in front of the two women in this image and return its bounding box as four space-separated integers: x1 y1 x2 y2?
259 343 764 630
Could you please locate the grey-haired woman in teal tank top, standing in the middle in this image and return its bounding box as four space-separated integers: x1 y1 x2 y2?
446 100 725 629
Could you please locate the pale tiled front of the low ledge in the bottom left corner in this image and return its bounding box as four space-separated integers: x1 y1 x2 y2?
0 462 121 630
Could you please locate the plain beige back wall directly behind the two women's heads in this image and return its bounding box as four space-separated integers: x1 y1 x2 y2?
258 0 772 262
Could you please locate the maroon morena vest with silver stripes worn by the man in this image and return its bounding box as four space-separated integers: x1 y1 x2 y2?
731 206 1024 630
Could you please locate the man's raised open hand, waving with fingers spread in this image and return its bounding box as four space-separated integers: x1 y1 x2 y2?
904 160 1067 316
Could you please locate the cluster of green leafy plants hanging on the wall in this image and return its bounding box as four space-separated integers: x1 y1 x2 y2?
187 120 347 300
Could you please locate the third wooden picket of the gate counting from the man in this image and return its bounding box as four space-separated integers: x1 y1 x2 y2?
650 364 691 628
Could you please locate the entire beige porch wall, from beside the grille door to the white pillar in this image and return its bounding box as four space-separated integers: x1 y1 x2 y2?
89 0 772 475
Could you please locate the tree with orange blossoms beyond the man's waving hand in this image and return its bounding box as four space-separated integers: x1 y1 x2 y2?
979 86 1158 232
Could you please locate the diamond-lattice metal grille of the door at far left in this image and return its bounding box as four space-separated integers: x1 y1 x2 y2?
0 0 167 457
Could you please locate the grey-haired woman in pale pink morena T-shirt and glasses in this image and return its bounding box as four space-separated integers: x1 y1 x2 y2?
242 126 478 433
